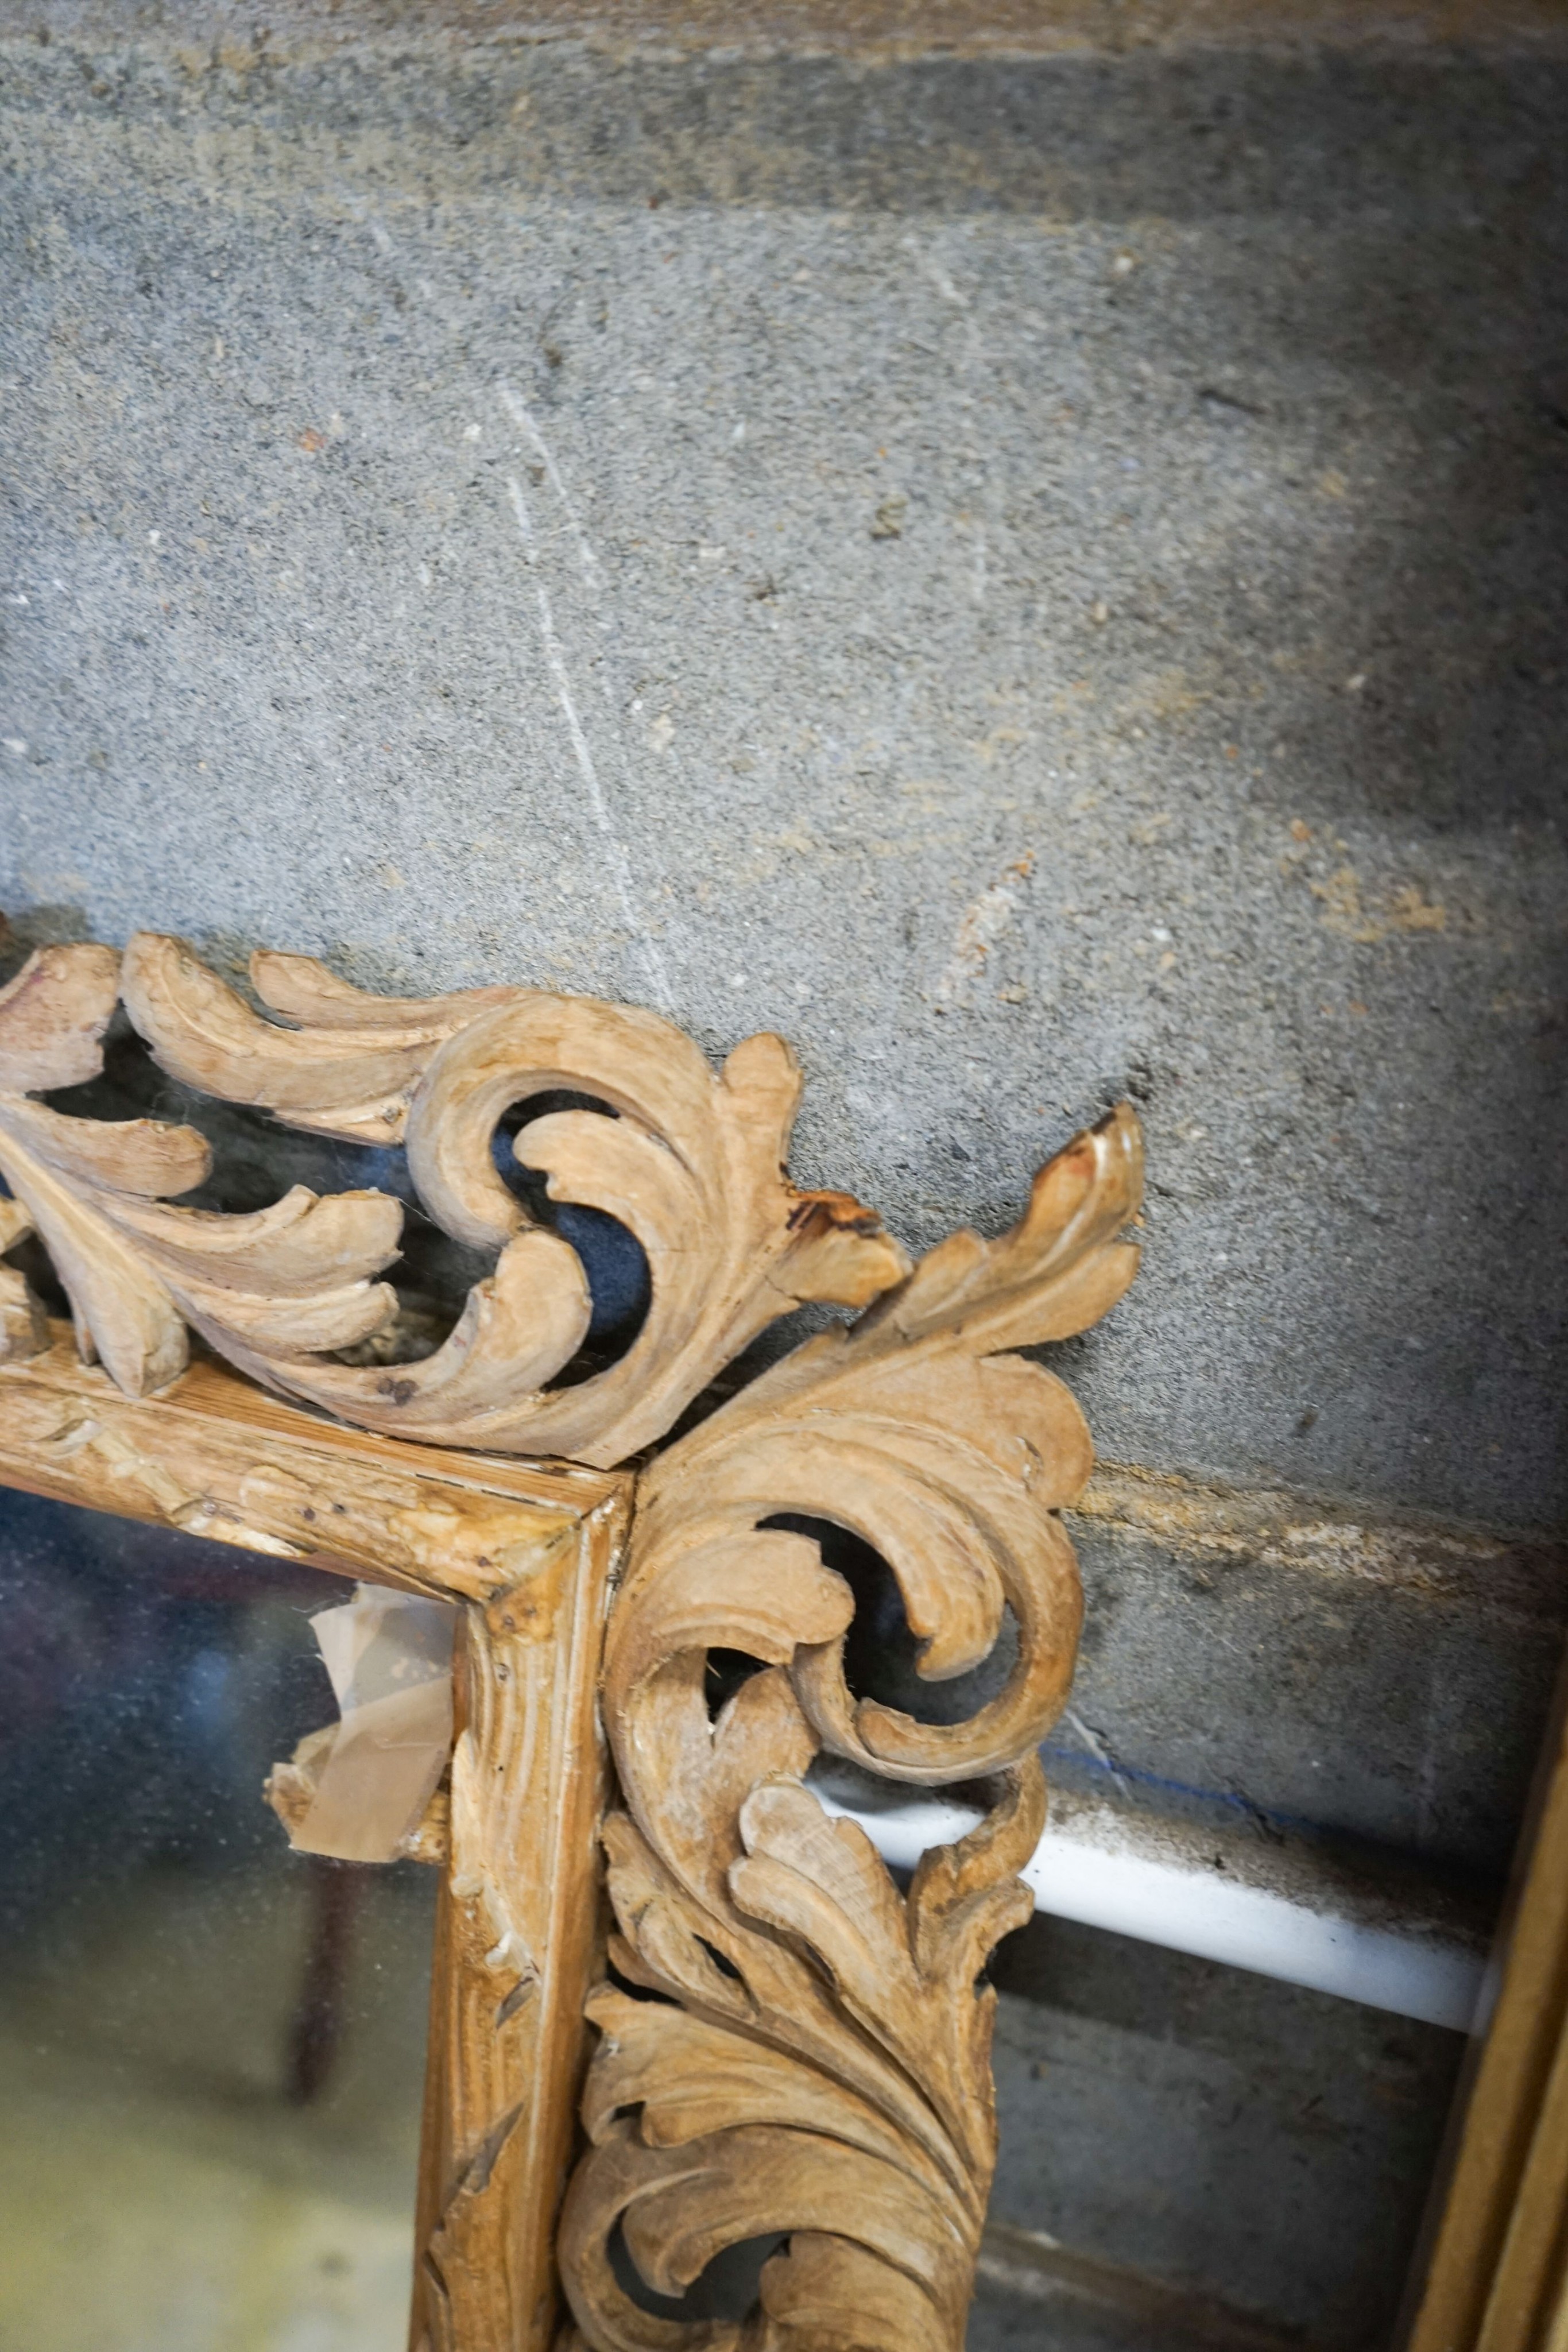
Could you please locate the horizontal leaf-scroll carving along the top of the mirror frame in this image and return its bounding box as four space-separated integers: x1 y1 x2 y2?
0 931 907 1468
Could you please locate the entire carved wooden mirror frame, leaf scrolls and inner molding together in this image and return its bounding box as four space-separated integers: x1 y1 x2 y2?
0 934 1140 2352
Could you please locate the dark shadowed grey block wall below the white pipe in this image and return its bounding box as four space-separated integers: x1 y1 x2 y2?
987 1917 1465 2352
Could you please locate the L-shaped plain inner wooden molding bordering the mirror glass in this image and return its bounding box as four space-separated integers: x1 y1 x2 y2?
0 1324 630 2352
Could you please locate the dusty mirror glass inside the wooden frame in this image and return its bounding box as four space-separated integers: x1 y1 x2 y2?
0 1489 435 2352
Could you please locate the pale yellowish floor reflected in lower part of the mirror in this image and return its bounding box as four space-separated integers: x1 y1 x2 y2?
0 1858 432 2352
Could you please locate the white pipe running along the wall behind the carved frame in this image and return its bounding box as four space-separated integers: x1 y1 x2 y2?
816 1790 1486 2032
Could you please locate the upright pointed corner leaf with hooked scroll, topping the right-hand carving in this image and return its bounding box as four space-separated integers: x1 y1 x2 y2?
620 1108 1143 1783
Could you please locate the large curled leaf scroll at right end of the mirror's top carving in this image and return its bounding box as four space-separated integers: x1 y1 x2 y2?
287 995 907 1468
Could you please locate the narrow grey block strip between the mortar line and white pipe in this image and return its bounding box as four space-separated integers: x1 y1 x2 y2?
1062 1538 1563 1877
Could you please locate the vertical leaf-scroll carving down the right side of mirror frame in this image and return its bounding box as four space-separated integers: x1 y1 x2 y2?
562 1108 1140 2352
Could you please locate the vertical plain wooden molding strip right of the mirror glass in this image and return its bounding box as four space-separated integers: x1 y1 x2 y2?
409 1503 623 2352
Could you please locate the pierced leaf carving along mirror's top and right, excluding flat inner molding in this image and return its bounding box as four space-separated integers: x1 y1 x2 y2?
0 934 1140 2352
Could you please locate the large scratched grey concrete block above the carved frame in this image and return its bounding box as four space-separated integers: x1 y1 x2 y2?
0 33 1568 1524
